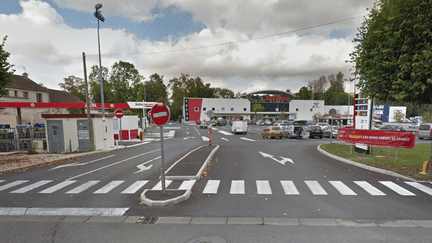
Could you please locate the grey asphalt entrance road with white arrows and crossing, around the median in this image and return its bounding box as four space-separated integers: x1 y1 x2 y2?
0 124 432 220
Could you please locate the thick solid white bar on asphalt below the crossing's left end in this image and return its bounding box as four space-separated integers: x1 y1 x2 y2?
25 208 129 216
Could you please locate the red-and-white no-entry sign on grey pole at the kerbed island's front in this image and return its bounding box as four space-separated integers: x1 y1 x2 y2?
149 104 170 194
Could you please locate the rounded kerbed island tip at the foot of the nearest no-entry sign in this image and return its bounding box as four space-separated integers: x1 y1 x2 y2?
141 189 192 207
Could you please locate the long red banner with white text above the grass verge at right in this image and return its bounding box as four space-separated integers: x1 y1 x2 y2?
338 128 415 148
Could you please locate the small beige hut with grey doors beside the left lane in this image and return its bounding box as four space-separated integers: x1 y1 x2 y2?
42 114 114 152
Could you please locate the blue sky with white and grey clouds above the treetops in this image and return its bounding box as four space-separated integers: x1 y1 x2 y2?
0 0 375 96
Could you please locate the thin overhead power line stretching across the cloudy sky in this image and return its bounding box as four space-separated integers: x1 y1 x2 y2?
87 16 363 56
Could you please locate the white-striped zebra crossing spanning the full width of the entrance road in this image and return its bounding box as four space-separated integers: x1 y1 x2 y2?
0 180 432 197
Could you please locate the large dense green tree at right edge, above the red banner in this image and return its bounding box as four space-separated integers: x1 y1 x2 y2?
350 0 432 176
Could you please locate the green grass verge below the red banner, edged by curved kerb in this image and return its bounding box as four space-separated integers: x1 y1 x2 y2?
321 143 431 180
